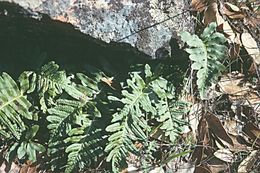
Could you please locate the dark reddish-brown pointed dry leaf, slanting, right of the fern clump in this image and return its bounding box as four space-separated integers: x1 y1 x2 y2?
206 112 234 145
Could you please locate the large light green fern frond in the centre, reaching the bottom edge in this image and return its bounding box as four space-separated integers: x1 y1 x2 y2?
105 68 156 172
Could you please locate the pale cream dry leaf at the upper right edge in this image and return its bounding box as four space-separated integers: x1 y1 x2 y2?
241 32 260 65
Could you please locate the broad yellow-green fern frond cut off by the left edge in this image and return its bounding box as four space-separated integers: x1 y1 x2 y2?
0 73 33 140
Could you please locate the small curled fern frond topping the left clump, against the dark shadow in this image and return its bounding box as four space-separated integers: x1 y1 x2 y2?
19 61 86 111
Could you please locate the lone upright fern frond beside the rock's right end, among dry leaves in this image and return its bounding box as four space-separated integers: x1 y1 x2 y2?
180 23 227 99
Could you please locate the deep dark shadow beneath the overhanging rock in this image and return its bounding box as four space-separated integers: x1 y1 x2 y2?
0 2 150 76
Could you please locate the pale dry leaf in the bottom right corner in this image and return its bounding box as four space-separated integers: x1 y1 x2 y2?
237 150 260 173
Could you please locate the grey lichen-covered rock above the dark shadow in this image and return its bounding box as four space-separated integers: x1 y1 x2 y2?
0 0 193 57
